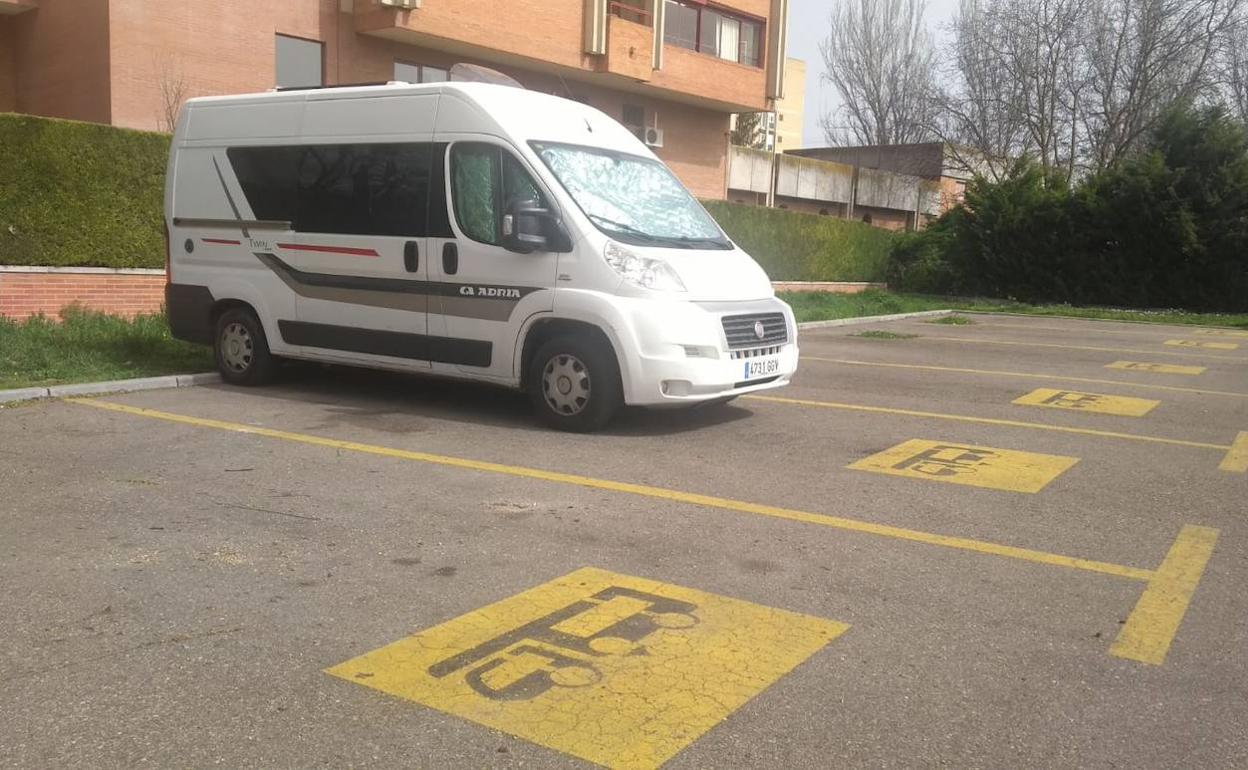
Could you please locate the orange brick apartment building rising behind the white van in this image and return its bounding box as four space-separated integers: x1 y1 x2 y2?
0 0 787 197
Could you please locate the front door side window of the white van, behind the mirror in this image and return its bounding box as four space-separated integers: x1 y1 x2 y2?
451 142 545 246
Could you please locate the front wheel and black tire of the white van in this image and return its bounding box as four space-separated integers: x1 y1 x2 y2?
528 336 624 433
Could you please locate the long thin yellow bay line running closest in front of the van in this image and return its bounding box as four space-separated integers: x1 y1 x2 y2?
65 398 1153 580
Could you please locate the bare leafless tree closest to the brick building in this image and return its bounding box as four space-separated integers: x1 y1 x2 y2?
819 0 936 145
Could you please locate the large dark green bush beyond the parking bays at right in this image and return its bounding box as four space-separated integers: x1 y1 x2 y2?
889 109 1248 311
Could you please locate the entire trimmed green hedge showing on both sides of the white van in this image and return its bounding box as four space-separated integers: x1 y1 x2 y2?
0 114 895 281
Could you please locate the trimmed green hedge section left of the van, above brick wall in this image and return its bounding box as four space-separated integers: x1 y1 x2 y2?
0 114 168 267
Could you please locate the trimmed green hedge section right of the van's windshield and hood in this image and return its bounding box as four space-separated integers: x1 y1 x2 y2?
703 201 896 281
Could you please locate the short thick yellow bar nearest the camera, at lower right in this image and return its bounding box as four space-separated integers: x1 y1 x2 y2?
1109 524 1218 665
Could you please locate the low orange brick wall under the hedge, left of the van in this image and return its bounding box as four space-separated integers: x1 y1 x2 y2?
0 267 165 321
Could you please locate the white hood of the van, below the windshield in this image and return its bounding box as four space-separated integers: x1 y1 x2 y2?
629 245 775 302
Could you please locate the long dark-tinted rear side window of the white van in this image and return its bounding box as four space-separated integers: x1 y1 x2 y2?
226 142 446 238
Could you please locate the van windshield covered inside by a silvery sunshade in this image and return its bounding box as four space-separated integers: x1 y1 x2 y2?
533 142 733 248
